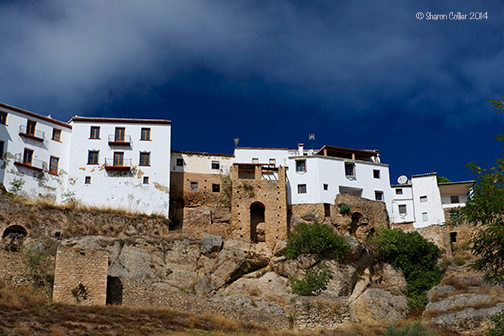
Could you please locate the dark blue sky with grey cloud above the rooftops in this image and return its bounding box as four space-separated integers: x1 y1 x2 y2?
0 0 504 183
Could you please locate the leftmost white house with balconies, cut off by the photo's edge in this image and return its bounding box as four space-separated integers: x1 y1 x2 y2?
0 103 72 203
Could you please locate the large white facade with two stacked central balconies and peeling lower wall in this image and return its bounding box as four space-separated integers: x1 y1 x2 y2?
68 117 171 216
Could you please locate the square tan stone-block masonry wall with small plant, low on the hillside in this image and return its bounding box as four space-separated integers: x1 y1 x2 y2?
53 246 108 306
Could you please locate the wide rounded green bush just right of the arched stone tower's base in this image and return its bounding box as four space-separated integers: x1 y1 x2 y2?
283 222 351 261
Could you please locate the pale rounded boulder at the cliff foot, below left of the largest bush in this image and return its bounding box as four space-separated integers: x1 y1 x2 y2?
350 288 409 323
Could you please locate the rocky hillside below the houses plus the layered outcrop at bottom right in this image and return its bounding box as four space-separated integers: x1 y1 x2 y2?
0 197 503 333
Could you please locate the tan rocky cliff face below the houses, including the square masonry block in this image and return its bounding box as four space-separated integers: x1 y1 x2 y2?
0 198 407 329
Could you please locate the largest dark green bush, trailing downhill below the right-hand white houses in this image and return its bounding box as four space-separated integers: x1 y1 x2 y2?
368 227 443 309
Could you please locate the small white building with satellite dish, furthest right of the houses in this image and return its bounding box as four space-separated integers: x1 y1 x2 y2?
391 173 473 228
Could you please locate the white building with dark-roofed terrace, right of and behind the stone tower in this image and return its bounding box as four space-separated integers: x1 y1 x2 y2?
235 144 392 212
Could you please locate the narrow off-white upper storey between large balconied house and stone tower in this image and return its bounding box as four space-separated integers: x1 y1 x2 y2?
170 151 234 176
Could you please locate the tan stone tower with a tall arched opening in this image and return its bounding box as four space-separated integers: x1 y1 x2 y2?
231 164 287 246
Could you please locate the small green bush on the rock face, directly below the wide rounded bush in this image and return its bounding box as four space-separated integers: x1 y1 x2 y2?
289 266 332 296
